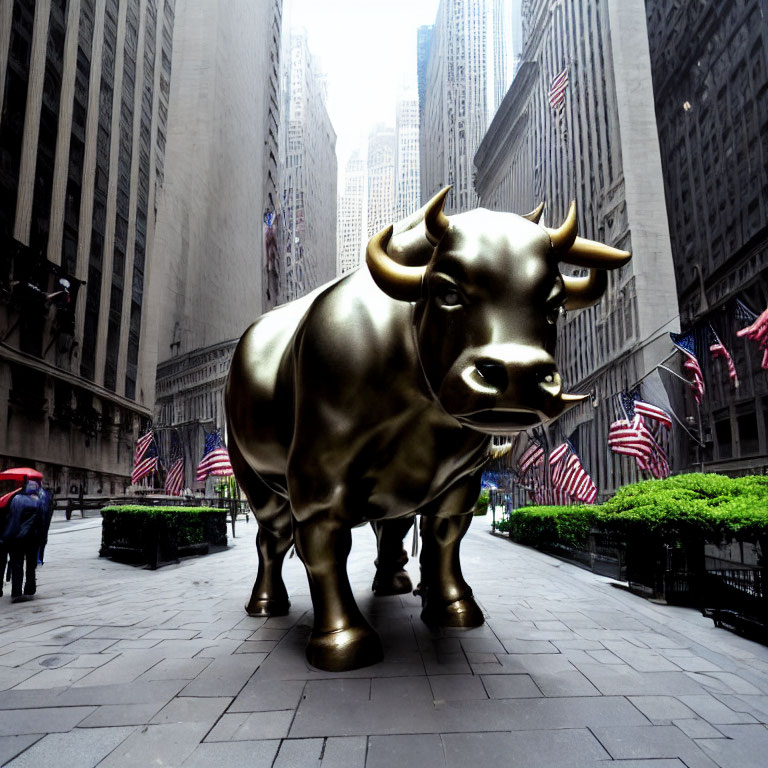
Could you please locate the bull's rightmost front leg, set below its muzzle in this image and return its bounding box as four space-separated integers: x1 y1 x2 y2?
420 474 484 627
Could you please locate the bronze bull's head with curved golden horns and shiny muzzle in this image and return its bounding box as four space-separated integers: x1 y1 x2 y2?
366 187 630 434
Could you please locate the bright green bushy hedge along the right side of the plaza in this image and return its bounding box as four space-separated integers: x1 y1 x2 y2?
502 473 768 553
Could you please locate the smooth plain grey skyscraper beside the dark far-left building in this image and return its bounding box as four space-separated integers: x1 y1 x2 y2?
155 0 282 362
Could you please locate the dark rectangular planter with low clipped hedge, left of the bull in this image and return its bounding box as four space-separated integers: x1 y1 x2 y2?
99 506 227 570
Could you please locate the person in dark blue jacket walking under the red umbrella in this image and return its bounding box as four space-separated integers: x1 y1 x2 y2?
0 480 45 603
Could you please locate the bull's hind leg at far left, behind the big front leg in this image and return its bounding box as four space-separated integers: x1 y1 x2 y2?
229 441 293 616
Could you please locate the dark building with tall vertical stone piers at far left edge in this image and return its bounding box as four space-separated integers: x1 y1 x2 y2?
0 0 176 494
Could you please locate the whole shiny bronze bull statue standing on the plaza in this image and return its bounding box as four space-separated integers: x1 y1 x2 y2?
226 189 630 671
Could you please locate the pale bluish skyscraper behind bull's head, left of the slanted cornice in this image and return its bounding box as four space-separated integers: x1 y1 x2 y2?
421 0 509 213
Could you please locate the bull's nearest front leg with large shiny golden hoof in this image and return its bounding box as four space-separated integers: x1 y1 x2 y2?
294 513 383 672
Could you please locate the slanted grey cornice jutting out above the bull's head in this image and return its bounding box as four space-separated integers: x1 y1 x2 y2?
474 61 539 197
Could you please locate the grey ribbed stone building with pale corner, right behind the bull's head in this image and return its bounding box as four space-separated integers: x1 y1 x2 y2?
475 0 679 494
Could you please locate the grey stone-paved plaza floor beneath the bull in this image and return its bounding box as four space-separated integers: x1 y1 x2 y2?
0 510 768 768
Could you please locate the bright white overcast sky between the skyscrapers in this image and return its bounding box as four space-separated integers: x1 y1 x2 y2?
283 0 439 174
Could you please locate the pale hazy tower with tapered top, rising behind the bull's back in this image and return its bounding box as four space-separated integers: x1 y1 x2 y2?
280 31 338 303
